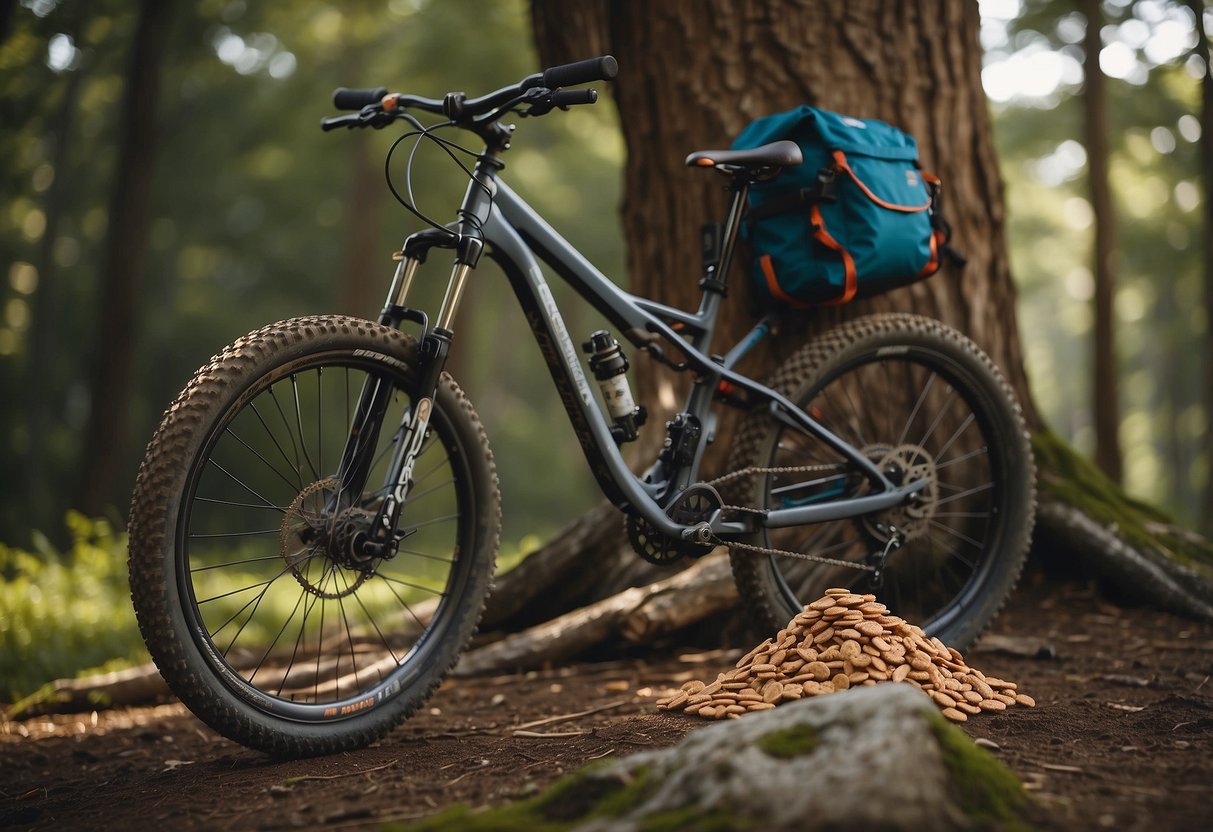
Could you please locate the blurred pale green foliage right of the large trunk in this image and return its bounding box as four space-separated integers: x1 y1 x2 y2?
989 0 1213 525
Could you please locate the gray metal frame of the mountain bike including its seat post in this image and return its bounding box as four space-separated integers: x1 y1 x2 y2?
388 160 926 538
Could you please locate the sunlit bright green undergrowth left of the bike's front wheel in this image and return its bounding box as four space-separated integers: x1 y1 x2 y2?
0 513 147 701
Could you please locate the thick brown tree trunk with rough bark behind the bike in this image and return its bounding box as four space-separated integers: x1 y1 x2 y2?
533 0 1036 465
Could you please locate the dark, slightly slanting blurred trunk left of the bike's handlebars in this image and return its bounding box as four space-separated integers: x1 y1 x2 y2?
76 0 173 514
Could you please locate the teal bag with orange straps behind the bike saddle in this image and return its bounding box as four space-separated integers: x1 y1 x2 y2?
733 107 949 308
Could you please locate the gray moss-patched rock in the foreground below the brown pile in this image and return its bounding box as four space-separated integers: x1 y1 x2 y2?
562 684 1023 832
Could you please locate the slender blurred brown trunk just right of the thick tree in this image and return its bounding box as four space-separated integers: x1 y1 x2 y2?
1082 0 1122 484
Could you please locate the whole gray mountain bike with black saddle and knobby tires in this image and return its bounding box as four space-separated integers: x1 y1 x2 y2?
130 56 1035 757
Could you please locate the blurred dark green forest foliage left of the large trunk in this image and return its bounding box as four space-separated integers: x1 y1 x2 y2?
0 0 611 545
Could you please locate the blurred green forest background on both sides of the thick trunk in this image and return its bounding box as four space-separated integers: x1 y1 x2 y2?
0 0 1213 693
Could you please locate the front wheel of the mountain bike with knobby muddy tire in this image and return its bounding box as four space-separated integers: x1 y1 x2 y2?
130 317 500 757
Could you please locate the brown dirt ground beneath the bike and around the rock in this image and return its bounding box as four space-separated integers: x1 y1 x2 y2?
0 560 1213 832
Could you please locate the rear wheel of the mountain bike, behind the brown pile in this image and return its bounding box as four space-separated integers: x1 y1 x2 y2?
729 314 1035 648
